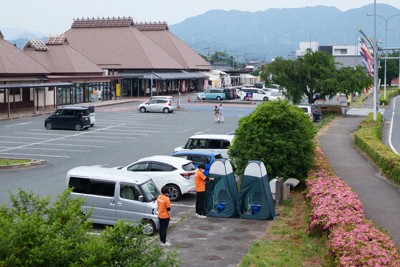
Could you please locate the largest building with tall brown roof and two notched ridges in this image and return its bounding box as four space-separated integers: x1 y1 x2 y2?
65 17 211 96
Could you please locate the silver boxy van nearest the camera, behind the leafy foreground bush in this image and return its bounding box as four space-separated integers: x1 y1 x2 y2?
66 166 160 234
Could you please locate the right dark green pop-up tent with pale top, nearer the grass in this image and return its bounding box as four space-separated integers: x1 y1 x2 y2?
237 161 275 220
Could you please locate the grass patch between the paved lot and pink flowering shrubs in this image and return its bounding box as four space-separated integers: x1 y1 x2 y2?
240 191 336 267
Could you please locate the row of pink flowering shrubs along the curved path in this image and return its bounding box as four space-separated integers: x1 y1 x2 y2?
307 147 400 266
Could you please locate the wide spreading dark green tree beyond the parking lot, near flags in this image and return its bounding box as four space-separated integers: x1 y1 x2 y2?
261 50 373 104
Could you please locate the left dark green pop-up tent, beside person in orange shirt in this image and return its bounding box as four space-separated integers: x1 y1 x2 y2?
205 159 238 218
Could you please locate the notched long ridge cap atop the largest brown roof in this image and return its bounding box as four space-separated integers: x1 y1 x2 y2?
71 17 133 28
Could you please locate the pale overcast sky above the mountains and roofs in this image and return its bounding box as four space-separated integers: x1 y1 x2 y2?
0 0 400 35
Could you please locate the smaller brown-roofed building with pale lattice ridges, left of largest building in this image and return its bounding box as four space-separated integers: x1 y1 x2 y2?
23 35 117 105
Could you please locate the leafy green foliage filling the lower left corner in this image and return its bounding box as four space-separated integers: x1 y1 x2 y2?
0 190 179 266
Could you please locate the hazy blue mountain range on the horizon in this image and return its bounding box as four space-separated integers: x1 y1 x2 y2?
1 4 400 62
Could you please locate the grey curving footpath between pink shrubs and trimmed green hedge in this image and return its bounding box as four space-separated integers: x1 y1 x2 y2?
318 97 400 247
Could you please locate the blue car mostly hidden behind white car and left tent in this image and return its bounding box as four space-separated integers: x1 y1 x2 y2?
171 150 223 177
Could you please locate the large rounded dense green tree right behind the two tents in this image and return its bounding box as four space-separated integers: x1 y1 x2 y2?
228 100 316 181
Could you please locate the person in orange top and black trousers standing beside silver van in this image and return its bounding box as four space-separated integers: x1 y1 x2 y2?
157 186 171 247
